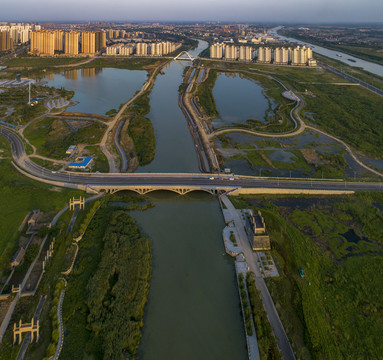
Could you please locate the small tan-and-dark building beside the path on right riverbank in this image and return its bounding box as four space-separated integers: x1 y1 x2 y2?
246 210 271 251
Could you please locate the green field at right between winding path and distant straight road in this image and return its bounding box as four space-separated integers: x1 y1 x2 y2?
250 65 383 157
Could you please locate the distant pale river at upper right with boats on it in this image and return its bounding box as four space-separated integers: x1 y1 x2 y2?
270 26 383 76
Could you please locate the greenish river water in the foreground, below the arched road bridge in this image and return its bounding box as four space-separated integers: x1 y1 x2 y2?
130 192 247 360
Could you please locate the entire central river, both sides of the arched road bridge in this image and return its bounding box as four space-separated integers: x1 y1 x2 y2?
132 41 247 360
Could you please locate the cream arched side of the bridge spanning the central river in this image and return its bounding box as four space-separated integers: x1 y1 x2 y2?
86 185 238 195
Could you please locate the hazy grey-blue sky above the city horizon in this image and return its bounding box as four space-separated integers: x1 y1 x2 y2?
0 0 383 24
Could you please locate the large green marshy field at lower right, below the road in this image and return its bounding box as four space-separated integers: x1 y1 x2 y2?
234 193 383 359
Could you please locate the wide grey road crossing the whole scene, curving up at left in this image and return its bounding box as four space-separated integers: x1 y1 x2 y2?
0 127 383 191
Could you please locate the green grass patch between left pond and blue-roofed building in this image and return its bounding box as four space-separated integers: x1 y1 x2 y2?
24 118 106 159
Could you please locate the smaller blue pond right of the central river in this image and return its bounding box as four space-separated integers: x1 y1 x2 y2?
212 73 275 128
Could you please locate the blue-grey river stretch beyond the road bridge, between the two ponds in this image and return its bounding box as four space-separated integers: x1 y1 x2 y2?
137 41 208 172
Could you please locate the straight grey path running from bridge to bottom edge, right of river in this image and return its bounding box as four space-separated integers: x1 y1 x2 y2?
221 195 295 360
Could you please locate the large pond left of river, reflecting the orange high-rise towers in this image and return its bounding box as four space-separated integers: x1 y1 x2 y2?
44 68 147 115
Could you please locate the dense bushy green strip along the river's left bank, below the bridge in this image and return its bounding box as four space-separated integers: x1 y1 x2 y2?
62 207 151 359
